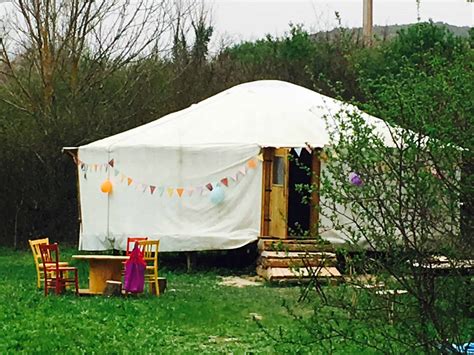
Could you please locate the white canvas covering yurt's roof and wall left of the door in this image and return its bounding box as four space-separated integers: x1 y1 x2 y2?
78 81 393 251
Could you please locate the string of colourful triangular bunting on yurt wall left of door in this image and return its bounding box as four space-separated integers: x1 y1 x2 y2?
75 156 260 198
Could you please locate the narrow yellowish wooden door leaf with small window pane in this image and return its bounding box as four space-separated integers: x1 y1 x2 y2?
268 148 289 238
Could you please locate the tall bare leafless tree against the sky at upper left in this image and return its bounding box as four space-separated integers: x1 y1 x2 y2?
0 0 198 123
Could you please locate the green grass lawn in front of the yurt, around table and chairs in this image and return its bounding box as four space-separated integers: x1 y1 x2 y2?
4 249 472 354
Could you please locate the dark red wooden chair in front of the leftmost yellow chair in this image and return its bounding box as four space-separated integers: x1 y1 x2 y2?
39 244 79 296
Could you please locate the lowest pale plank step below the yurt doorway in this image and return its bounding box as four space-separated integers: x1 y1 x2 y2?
257 266 342 281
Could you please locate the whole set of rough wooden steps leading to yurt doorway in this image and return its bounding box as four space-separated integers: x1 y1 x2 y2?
257 238 342 282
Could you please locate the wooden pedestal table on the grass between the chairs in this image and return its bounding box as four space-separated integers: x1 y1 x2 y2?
72 255 128 295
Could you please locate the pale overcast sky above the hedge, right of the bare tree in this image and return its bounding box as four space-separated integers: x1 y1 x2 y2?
204 0 474 41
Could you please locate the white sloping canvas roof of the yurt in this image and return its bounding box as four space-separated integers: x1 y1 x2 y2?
78 80 391 149
